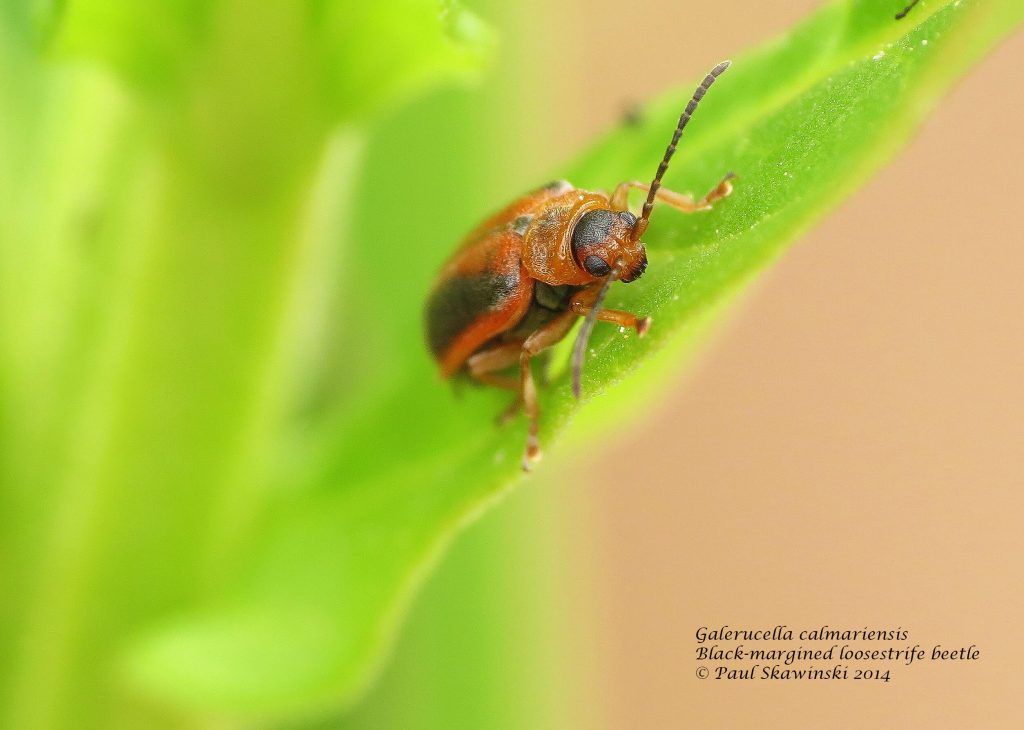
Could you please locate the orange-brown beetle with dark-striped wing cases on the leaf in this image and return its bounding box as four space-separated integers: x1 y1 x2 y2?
425 61 733 470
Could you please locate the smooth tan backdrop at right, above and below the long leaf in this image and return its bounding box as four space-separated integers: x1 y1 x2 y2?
528 0 1024 728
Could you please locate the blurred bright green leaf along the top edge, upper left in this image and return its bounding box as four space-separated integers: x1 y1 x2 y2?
47 0 493 122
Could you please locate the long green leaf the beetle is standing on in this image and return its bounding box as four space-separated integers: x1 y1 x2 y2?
126 0 1024 718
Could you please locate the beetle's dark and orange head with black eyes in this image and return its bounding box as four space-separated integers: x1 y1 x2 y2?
572 208 647 282
